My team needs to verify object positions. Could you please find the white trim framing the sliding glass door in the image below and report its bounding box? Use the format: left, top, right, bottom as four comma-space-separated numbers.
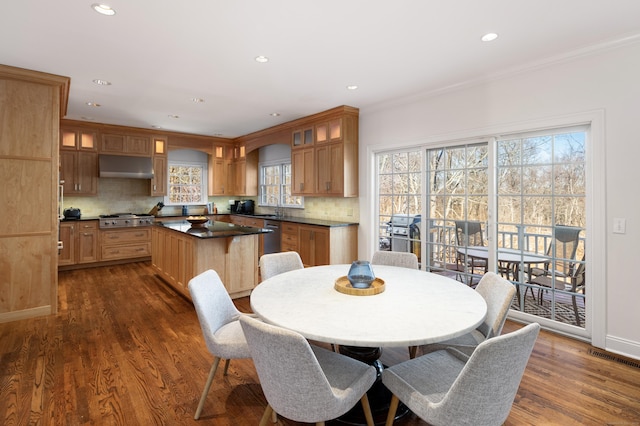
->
360, 109, 604, 353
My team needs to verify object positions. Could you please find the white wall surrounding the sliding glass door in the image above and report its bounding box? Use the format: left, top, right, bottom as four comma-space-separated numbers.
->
359, 38, 640, 358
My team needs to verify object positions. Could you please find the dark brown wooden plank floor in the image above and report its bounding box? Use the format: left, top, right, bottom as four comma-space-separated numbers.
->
0, 263, 640, 426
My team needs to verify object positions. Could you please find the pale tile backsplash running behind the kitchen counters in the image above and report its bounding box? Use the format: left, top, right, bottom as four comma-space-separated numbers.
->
64, 178, 360, 222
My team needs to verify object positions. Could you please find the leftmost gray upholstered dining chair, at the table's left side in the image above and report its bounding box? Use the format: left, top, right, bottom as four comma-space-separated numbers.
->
188, 269, 251, 420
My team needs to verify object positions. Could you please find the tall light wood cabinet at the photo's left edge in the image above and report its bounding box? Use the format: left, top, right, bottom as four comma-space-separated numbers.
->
0, 65, 69, 322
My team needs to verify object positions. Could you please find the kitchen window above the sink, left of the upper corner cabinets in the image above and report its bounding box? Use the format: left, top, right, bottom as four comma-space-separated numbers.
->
259, 163, 304, 208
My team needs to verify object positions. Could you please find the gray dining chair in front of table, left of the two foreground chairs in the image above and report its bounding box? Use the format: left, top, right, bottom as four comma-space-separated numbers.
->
240, 317, 376, 426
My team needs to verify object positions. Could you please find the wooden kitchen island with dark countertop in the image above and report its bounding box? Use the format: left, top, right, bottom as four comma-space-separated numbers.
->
151, 220, 271, 299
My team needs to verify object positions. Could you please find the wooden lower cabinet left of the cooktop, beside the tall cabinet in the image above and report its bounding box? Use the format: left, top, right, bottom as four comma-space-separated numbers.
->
58, 220, 99, 266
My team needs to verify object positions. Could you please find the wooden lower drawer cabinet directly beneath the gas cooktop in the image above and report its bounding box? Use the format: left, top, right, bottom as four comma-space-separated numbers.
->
100, 227, 151, 261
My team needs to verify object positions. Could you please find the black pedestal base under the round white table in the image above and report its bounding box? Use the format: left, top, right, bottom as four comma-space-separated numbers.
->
336, 346, 409, 425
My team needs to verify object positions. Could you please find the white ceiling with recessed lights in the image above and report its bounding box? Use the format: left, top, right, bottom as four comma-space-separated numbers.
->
0, 0, 640, 137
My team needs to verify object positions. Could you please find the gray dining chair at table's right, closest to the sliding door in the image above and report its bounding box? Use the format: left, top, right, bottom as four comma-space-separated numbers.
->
416, 272, 516, 358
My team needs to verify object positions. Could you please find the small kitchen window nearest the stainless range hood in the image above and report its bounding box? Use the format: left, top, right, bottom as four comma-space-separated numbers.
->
165, 150, 208, 206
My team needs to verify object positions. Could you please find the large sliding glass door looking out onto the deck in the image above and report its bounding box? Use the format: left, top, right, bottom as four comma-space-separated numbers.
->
376, 127, 588, 328
